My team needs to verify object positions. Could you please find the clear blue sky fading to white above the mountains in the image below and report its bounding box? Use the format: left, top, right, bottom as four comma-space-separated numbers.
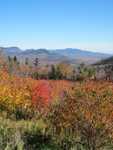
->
0, 0, 113, 53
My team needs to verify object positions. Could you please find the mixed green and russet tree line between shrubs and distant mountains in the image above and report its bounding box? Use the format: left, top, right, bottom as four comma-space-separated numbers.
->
7, 56, 95, 81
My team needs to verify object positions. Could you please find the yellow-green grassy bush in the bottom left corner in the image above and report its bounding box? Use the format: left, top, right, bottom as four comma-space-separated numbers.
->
0, 118, 58, 150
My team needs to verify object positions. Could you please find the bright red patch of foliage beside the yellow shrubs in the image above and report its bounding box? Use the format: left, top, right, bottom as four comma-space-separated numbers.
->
32, 80, 51, 106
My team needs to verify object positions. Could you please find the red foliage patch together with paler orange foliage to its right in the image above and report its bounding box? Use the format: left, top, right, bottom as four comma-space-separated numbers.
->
32, 80, 72, 105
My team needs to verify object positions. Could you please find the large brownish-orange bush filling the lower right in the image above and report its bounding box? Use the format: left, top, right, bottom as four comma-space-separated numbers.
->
47, 82, 113, 150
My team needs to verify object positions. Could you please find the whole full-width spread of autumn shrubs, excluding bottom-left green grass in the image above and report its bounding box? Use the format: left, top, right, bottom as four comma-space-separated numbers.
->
0, 68, 113, 150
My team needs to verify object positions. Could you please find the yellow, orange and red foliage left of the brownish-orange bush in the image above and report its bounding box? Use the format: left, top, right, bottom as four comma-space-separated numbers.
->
0, 71, 71, 115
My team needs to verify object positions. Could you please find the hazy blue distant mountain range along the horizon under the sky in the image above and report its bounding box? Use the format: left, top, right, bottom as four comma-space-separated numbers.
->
0, 47, 111, 64
